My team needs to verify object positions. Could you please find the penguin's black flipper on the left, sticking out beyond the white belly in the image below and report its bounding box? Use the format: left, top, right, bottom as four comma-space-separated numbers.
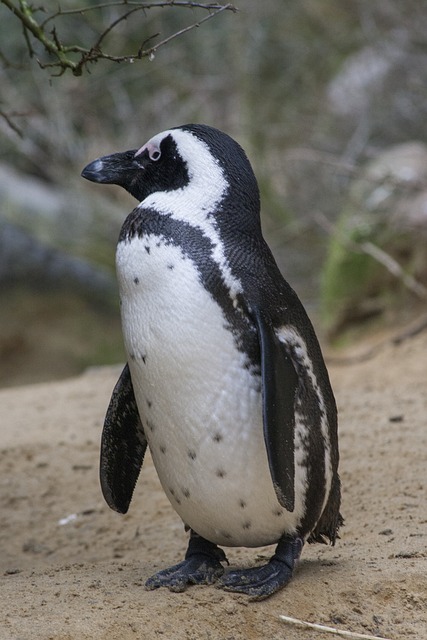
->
99, 365, 147, 513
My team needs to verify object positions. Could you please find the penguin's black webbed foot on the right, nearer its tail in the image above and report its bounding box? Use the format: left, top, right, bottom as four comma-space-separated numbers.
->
218, 538, 303, 600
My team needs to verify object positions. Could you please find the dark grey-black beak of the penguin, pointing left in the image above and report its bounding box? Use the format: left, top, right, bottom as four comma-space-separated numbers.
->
81, 149, 142, 186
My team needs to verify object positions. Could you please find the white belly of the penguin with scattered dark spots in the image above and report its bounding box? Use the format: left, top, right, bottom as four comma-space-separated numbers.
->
117, 235, 305, 547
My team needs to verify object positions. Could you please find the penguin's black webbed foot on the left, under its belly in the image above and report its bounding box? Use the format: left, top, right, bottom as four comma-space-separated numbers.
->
145, 532, 228, 592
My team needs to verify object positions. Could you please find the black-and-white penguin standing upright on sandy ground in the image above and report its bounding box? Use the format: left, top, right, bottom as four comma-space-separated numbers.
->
82, 124, 343, 599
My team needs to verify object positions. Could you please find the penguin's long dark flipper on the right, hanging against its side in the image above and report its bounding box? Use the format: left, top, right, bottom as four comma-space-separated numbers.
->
253, 308, 298, 511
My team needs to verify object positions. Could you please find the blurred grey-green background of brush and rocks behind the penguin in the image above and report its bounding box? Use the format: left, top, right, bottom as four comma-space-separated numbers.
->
0, 0, 427, 386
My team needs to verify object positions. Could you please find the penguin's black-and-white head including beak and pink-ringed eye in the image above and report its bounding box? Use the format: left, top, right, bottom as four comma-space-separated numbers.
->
82, 124, 259, 225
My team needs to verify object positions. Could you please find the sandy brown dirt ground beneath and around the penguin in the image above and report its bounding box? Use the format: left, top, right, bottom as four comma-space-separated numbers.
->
0, 322, 427, 640
